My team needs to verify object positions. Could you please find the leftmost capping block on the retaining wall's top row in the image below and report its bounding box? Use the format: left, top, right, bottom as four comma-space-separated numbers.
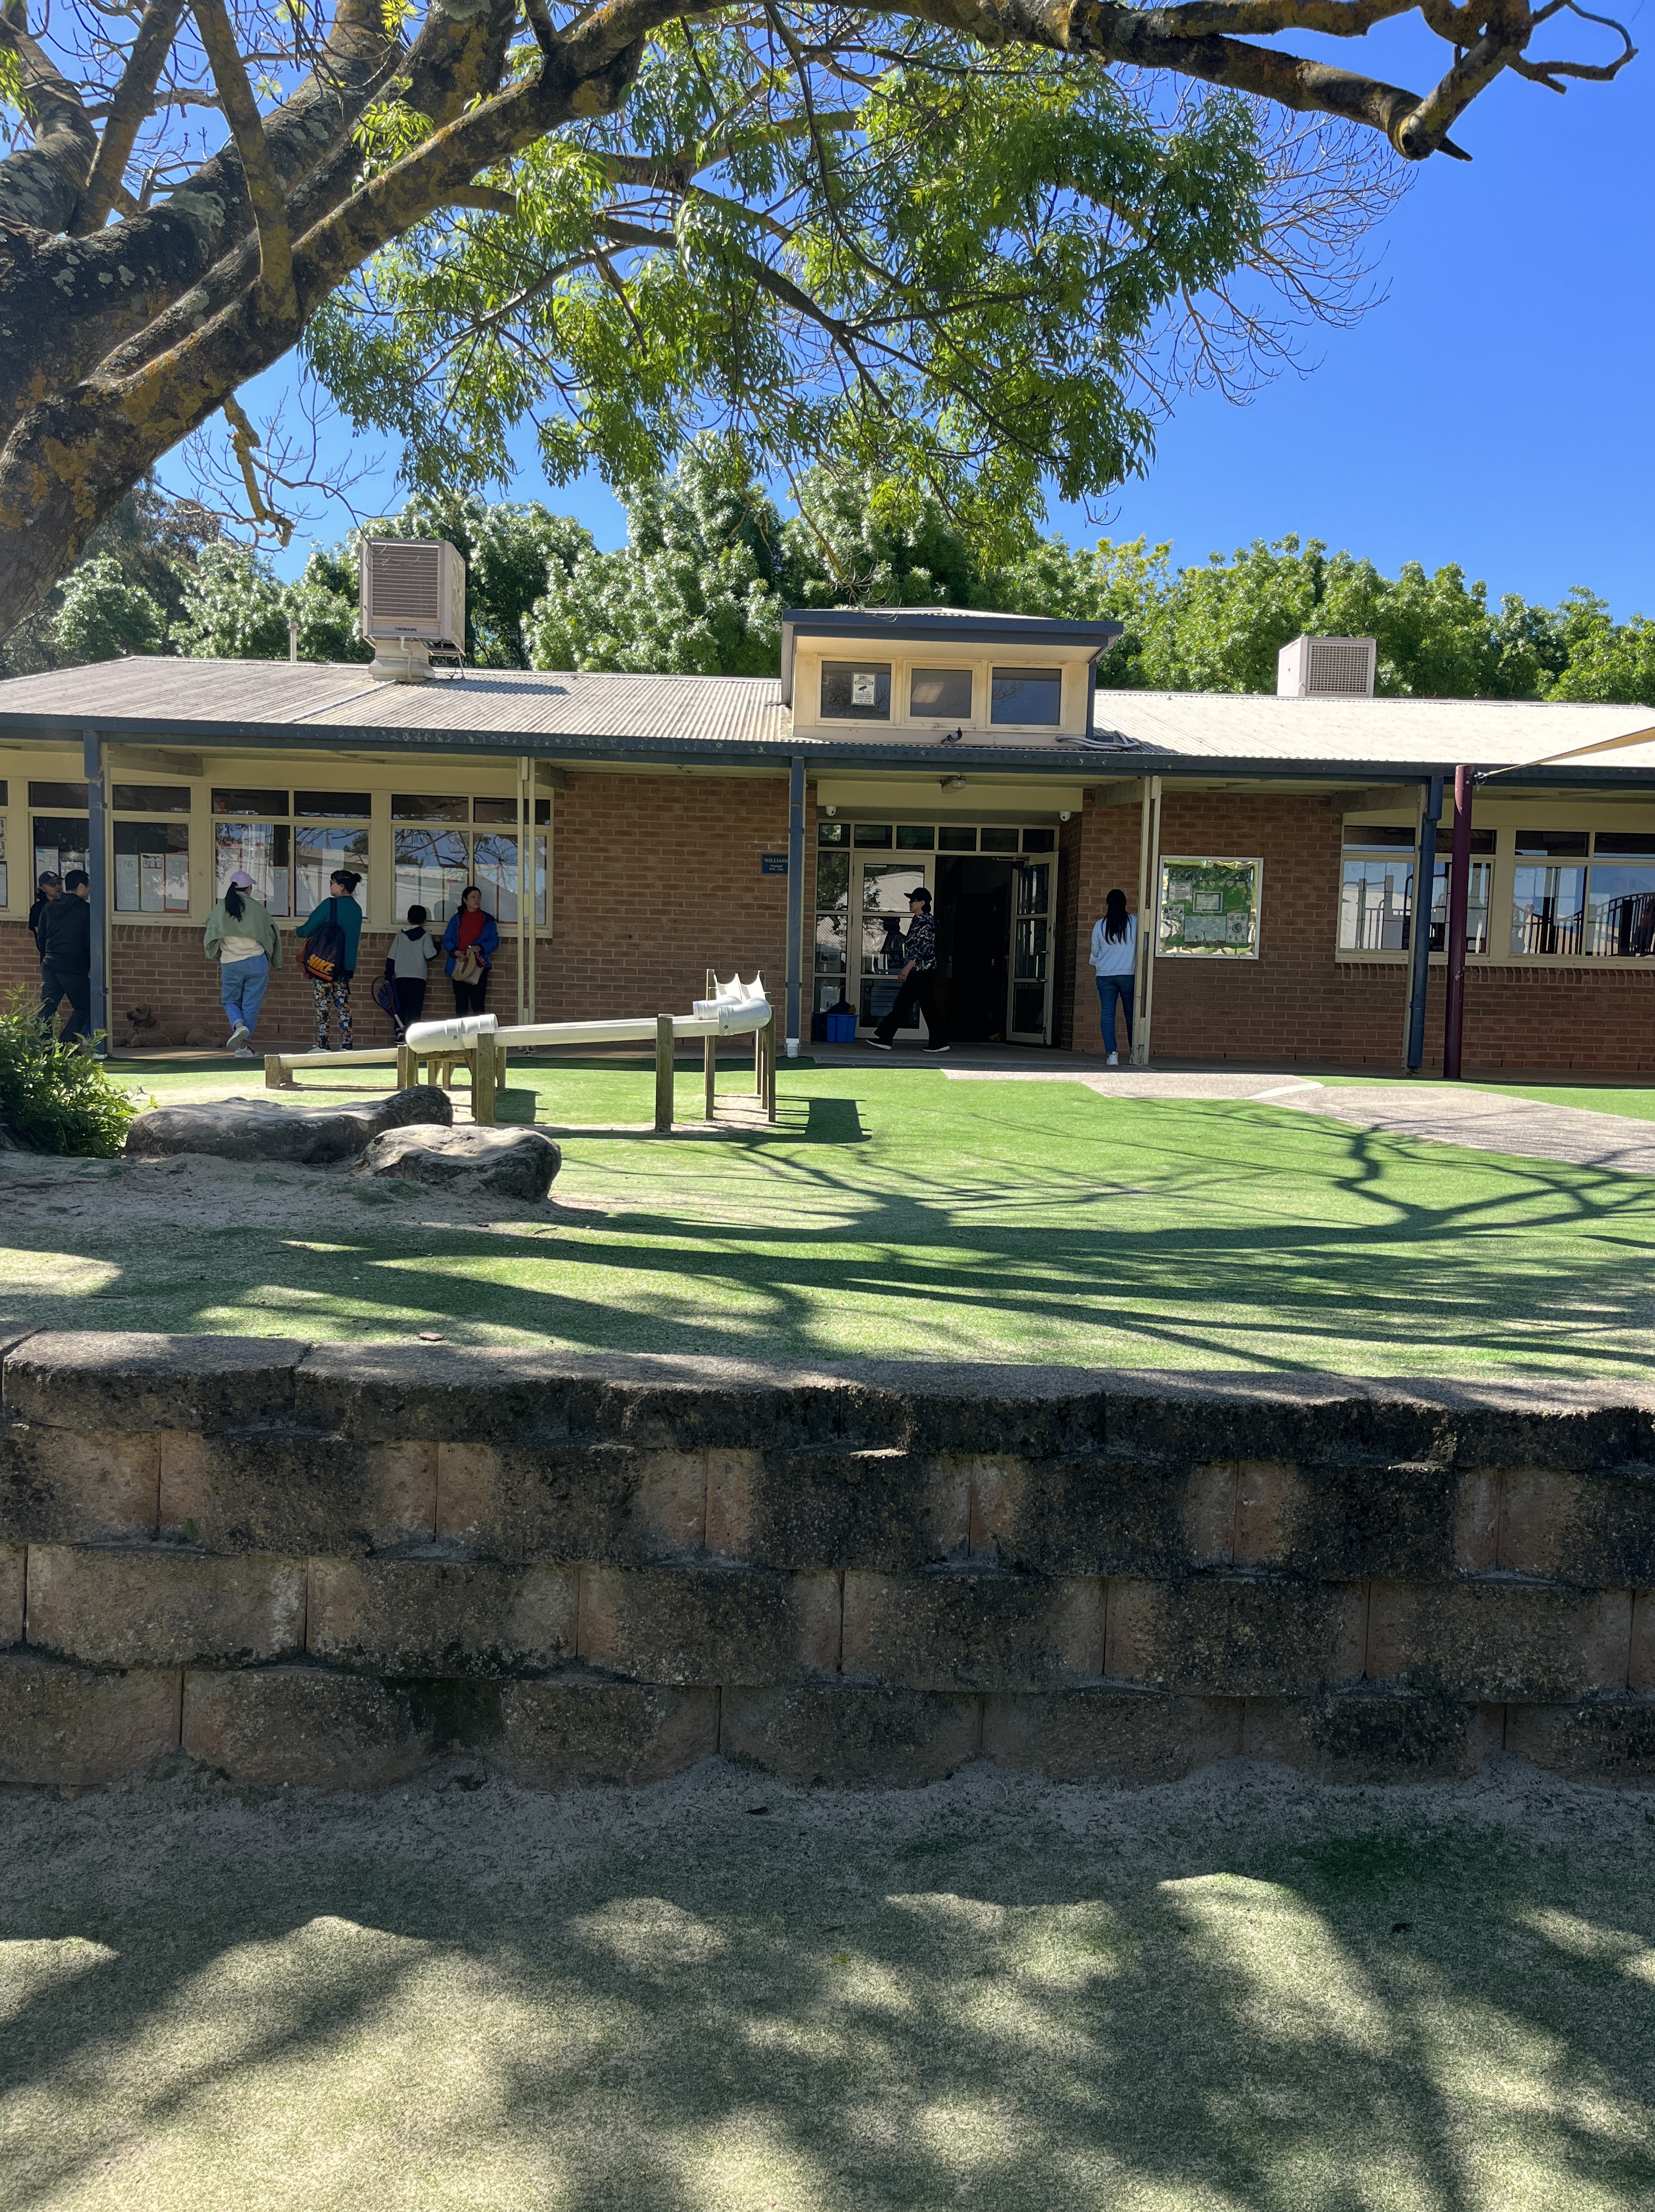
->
0, 1329, 310, 1431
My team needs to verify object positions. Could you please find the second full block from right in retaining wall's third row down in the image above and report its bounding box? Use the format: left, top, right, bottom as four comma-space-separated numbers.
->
1104, 1570, 1365, 1697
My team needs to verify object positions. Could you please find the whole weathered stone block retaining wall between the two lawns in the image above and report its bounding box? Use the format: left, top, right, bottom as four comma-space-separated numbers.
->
0, 1334, 1655, 1788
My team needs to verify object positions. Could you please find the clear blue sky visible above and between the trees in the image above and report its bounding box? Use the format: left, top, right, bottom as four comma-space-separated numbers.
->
248, 11, 1655, 617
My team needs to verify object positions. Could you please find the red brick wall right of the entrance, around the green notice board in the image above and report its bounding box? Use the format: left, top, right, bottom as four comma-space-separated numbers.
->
1073, 790, 1655, 1075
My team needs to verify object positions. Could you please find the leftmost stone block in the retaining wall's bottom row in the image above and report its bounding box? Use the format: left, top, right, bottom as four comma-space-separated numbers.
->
0, 1652, 179, 1790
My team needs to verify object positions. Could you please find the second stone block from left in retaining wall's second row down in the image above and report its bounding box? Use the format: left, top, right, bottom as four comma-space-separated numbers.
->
161, 1429, 436, 1553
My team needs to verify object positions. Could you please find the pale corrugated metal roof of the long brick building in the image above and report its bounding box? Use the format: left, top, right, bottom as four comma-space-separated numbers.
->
0, 657, 1655, 781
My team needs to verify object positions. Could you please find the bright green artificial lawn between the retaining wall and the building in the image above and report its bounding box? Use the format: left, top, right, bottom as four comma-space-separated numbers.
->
0, 1064, 1655, 1378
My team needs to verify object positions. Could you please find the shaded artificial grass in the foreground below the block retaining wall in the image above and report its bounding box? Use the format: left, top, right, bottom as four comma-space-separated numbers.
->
0, 1761, 1655, 2212
